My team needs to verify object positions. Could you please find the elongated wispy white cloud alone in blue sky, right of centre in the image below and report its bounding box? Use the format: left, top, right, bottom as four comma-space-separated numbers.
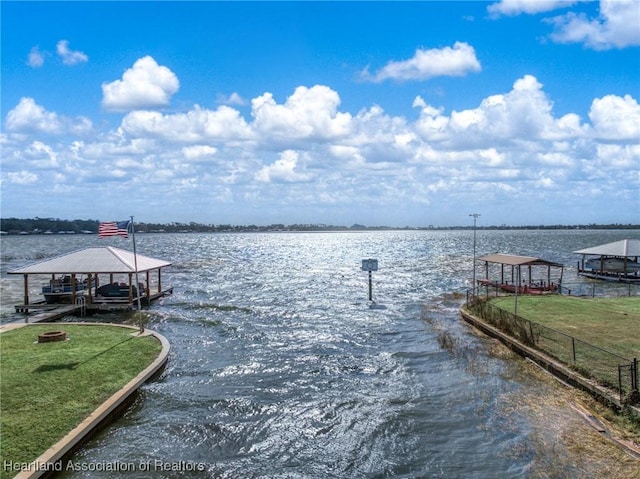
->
362, 42, 481, 82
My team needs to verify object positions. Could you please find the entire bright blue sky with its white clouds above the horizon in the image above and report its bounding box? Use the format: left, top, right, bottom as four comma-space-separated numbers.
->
0, 0, 640, 227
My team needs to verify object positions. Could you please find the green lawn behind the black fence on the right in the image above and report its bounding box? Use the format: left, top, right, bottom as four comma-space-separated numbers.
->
491, 295, 640, 359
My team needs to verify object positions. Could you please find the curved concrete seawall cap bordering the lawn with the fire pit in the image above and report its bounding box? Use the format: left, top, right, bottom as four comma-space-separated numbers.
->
2, 323, 171, 479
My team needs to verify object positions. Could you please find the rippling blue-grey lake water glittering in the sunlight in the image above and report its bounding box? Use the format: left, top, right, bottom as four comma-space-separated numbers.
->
1, 230, 640, 478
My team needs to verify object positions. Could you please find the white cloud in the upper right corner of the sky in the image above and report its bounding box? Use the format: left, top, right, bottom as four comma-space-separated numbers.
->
549, 0, 640, 50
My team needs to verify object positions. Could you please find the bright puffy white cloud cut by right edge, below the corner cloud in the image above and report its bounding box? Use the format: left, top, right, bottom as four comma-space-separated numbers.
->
589, 95, 640, 142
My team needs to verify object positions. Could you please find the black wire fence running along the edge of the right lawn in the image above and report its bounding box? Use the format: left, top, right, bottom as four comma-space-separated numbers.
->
467, 293, 639, 403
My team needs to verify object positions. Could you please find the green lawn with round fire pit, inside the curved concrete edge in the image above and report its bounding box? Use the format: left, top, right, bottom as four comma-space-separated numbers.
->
0, 324, 162, 479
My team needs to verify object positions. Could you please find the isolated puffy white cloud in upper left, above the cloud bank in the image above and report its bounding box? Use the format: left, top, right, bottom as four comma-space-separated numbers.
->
102, 56, 180, 111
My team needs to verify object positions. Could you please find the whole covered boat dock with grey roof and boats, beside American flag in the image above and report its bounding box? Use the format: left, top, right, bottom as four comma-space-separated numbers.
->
8, 246, 173, 313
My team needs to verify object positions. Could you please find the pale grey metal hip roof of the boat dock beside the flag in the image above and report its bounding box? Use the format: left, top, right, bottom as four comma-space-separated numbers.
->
8, 246, 171, 274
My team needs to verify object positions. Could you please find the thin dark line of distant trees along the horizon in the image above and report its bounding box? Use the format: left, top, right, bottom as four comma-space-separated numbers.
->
0, 217, 640, 234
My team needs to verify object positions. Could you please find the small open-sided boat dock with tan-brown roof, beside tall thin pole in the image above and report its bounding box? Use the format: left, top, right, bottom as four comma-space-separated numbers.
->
478, 253, 564, 294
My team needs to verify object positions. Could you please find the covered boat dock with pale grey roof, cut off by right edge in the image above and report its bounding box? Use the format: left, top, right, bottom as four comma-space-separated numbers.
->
574, 239, 640, 283
